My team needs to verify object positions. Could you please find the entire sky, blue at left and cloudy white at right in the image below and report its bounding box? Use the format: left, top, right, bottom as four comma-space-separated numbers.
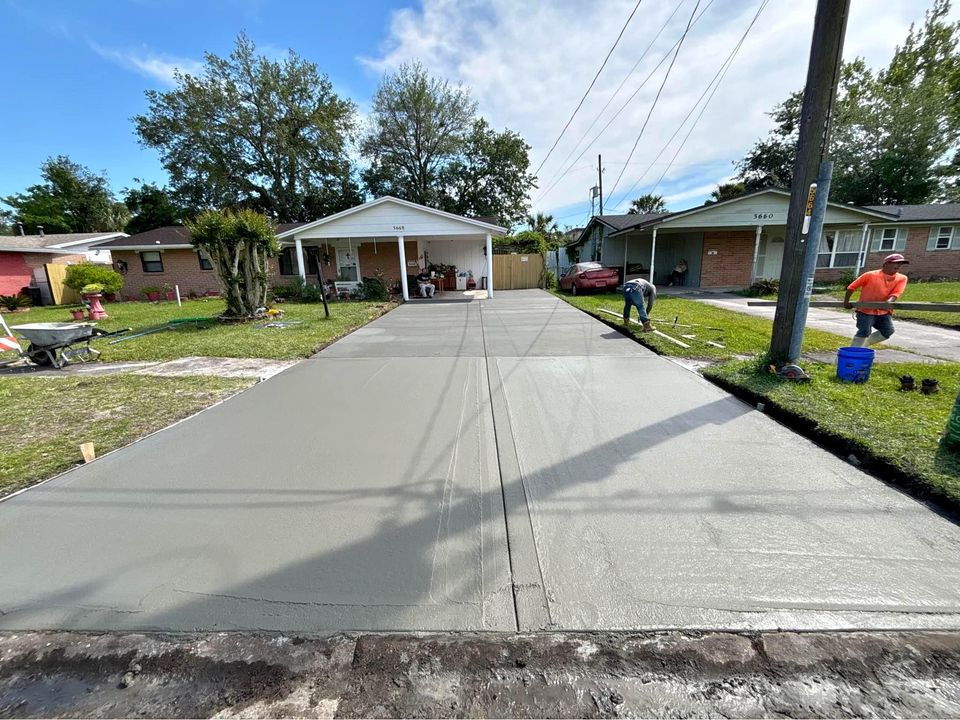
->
0, 0, 944, 225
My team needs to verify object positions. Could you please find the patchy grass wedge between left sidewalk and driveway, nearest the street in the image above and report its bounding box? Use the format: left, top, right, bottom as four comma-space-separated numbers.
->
0, 374, 252, 495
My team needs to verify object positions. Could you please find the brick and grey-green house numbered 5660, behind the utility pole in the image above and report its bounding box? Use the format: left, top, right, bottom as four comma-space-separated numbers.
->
568, 188, 960, 288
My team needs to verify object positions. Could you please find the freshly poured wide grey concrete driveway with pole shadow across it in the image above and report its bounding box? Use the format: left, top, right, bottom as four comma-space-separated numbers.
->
0, 291, 960, 631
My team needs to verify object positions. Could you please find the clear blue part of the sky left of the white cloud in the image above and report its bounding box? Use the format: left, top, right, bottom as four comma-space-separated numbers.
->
0, 0, 400, 196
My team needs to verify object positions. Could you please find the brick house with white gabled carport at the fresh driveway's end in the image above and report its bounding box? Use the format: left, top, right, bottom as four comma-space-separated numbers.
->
97, 196, 507, 299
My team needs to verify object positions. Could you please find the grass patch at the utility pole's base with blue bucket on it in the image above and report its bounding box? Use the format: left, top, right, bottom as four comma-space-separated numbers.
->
704, 361, 960, 507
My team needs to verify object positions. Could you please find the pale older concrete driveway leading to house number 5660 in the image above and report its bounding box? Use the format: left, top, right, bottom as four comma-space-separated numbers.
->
680, 291, 960, 362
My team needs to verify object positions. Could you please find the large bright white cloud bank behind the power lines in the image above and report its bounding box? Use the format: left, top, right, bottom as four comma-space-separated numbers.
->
361, 0, 956, 217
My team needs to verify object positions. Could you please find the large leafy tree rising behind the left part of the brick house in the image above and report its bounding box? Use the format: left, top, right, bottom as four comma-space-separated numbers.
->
134, 33, 362, 222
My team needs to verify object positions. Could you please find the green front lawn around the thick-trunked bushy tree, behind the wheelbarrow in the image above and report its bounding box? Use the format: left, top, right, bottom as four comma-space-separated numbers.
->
4, 298, 394, 361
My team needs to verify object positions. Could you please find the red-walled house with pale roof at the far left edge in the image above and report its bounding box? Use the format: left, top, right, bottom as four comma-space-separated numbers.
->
0, 232, 126, 303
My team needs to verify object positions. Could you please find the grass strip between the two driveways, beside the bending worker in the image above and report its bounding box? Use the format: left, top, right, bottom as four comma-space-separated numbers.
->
556, 292, 848, 360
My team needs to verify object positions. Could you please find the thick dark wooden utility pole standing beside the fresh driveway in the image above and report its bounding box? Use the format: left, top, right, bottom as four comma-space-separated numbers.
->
770, 0, 850, 362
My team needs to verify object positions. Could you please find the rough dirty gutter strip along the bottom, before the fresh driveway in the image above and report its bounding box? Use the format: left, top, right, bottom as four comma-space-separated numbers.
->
0, 632, 960, 718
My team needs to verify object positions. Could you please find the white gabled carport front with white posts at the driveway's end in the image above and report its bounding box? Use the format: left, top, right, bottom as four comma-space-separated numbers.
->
277, 196, 507, 301
